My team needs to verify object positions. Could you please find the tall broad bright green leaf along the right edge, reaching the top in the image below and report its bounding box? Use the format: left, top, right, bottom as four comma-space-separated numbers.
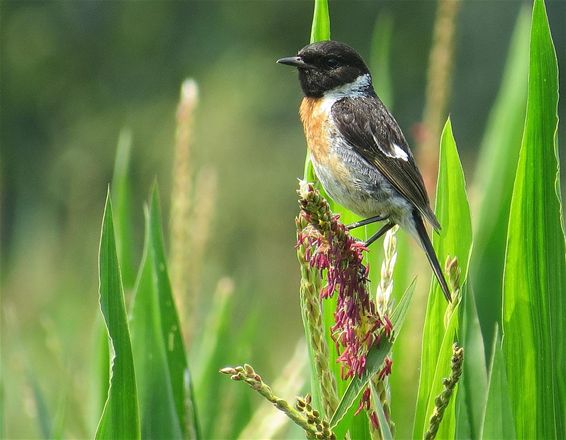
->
503, 0, 566, 438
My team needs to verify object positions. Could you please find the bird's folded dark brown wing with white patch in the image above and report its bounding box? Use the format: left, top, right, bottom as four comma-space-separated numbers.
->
331, 96, 440, 230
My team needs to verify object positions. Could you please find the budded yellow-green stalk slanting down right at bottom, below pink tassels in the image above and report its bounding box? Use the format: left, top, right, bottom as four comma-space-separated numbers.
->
220, 364, 336, 440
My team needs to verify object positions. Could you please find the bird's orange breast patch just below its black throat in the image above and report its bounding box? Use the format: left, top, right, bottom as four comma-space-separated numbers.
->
299, 98, 330, 163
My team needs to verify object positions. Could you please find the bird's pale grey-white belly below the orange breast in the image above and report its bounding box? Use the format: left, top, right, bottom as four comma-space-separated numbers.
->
312, 142, 412, 223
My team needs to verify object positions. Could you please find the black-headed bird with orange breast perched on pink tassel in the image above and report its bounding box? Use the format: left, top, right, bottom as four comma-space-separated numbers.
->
277, 40, 451, 302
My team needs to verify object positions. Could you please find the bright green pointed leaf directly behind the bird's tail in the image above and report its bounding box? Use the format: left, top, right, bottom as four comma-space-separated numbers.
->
413, 119, 472, 438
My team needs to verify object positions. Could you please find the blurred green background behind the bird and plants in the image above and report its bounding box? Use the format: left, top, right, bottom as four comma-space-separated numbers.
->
0, 0, 566, 438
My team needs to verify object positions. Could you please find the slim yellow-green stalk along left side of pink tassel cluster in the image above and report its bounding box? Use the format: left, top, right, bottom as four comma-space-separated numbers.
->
295, 211, 338, 416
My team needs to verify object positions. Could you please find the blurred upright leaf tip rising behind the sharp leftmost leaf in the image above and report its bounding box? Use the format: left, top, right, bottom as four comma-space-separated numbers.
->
112, 129, 135, 288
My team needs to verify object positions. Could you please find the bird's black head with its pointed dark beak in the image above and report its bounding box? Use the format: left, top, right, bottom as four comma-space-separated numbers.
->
277, 41, 372, 98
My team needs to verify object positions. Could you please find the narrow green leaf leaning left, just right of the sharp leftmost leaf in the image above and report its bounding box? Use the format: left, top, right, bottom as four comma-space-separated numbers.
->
149, 185, 200, 438
